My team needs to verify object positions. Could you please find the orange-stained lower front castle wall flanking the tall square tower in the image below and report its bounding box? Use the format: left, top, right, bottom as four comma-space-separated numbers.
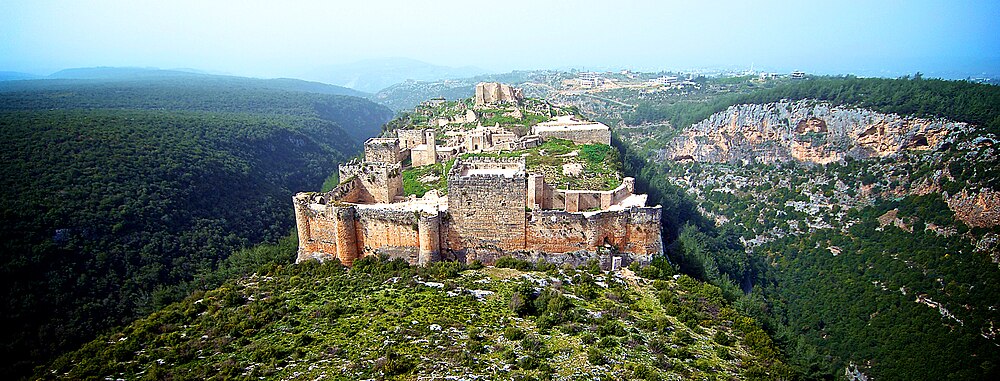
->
293, 189, 663, 269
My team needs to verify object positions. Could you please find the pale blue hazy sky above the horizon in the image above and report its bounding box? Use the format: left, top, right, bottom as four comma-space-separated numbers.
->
0, 0, 1000, 77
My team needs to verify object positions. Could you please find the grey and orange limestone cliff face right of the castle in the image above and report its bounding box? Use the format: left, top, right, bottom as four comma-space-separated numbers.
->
663, 100, 965, 164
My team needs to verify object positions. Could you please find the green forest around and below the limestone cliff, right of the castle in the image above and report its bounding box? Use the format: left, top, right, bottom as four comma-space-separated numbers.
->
616, 75, 1000, 379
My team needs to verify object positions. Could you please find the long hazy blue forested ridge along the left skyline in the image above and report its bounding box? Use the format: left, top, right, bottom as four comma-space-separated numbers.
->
0, 70, 382, 141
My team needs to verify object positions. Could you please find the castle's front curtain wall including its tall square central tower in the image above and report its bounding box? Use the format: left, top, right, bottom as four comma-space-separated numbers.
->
293, 158, 663, 269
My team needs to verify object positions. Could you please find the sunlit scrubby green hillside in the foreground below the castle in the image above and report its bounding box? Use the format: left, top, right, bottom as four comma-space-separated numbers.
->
35, 254, 787, 380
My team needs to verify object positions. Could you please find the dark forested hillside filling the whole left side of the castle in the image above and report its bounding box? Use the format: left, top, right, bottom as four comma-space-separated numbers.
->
0, 77, 391, 377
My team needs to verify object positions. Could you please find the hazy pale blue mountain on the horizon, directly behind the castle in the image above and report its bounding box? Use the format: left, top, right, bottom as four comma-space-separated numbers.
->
306, 58, 486, 93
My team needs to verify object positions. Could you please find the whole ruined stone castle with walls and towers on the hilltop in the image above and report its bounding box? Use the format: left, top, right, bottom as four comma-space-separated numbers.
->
293, 83, 663, 269
